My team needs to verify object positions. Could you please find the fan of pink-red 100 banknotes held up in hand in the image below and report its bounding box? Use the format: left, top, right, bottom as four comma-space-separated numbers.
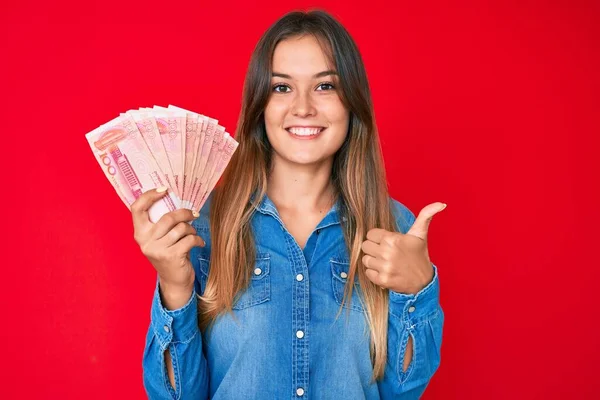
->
86, 105, 238, 222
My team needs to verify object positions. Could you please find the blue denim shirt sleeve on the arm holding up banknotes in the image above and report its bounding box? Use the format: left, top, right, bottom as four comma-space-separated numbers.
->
142, 277, 208, 400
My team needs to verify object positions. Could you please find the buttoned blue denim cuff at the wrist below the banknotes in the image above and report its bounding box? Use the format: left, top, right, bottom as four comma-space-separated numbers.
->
151, 279, 199, 349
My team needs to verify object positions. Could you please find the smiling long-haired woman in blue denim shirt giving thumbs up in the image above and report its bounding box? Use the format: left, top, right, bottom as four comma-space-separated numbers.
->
132, 7, 445, 400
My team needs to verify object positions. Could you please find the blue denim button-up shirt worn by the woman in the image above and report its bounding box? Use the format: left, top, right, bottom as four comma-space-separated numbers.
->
142, 195, 444, 400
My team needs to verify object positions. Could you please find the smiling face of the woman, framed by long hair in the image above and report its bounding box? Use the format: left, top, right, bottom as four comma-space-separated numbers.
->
264, 35, 350, 165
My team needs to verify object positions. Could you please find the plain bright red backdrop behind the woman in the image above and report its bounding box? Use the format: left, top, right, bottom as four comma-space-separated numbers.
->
0, 0, 600, 399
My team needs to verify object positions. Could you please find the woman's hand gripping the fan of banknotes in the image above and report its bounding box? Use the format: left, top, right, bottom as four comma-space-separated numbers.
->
131, 189, 205, 309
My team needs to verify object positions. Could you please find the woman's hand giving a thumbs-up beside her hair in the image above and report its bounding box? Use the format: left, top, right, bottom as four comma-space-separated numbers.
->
361, 202, 446, 294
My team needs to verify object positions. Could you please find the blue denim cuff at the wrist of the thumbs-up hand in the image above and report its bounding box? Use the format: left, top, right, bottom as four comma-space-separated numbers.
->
389, 264, 440, 321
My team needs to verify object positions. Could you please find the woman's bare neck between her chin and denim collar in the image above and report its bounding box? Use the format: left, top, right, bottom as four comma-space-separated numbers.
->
267, 155, 335, 212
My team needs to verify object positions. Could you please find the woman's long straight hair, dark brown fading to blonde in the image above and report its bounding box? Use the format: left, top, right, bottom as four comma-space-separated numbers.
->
199, 10, 396, 379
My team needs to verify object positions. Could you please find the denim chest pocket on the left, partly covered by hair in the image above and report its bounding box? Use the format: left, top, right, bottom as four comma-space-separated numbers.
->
198, 253, 271, 310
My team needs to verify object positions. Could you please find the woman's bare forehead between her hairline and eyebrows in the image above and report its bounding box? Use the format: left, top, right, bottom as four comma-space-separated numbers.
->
273, 35, 329, 77
